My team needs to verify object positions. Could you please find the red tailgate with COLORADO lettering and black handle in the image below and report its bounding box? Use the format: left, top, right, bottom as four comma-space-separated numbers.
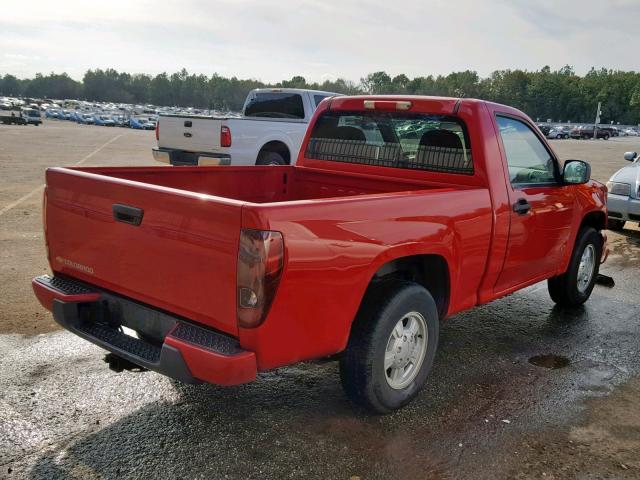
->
45, 168, 242, 335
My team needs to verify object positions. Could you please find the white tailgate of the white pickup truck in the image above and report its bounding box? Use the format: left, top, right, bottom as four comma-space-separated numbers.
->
158, 115, 224, 152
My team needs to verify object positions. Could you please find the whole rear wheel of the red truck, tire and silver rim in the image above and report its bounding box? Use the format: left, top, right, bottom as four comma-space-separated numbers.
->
340, 281, 439, 413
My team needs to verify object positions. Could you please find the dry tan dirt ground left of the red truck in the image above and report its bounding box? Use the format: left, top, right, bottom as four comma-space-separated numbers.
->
0, 121, 158, 334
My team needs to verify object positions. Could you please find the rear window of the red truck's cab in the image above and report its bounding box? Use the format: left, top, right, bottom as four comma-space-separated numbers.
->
305, 112, 473, 175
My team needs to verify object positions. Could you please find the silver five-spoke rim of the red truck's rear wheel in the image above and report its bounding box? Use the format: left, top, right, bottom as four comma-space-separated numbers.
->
384, 312, 428, 390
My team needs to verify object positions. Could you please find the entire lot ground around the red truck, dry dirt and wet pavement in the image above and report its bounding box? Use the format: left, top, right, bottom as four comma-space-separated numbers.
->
0, 121, 640, 479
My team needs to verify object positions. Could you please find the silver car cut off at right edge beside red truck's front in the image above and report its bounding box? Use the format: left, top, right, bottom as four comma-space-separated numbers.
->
607, 152, 640, 230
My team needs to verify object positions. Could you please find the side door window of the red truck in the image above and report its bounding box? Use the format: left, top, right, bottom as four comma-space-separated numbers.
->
497, 116, 557, 185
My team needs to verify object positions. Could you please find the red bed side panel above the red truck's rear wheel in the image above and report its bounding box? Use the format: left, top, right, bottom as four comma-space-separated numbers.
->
240, 188, 492, 369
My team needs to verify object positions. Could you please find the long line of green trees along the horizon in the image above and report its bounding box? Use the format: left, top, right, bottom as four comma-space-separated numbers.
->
0, 66, 640, 124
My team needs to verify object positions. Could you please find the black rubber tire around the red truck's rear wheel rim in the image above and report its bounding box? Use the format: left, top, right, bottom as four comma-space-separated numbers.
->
340, 281, 439, 413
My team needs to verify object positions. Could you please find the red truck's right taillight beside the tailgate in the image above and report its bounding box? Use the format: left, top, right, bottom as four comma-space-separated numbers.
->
236, 229, 284, 328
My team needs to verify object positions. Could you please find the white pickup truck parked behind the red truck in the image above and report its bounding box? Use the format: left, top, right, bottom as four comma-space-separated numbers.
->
153, 88, 337, 165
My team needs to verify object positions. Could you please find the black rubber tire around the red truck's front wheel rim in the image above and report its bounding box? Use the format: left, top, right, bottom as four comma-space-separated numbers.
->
547, 227, 602, 307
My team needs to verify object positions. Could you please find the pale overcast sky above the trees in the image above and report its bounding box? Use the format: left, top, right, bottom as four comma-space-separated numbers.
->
0, 0, 640, 82
